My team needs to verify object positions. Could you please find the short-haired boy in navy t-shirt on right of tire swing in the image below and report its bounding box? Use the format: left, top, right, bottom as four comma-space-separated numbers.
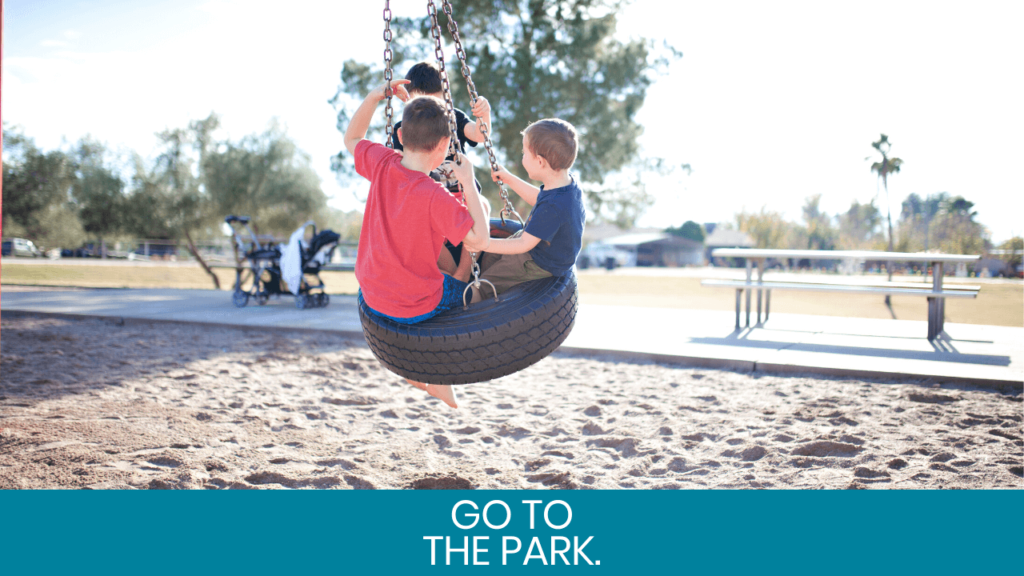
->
473, 118, 587, 302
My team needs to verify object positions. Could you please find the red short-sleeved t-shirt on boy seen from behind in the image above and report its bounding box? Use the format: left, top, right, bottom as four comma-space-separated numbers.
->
355, 140, 473, 318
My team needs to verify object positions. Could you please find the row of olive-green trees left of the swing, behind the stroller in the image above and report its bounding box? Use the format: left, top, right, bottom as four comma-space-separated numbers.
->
3, 114, 327, 248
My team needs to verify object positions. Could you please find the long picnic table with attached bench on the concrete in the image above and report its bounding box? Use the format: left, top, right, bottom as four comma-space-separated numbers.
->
701, 248, 981, 340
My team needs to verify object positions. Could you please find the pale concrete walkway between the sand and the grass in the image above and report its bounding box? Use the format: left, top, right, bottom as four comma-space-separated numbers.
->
0, 286, 1024, 392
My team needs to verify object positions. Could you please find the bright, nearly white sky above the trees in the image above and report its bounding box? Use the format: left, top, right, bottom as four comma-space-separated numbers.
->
0, 0, 1024, 243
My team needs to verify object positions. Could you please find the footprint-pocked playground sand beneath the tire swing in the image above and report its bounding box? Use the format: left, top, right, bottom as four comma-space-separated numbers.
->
0, 318, 1024, 489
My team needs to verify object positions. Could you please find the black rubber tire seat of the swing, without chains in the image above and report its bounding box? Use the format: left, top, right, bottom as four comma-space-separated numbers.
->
359, 271, 580, 384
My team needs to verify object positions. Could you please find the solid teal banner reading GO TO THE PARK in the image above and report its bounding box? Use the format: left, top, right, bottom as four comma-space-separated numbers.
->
0, 491, 1024, 576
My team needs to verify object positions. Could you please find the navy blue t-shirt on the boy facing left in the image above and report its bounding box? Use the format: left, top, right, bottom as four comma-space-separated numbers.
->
526, 178, 587, 276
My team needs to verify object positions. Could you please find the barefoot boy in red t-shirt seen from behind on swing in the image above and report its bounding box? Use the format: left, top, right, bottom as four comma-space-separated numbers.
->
345, 80, 490, 408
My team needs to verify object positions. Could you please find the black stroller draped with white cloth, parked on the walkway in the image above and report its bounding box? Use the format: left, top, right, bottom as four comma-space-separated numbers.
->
224, 215, 340, 310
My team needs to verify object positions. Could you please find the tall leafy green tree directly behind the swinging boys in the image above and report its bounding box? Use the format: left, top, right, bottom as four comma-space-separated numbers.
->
332, 0, 681, 227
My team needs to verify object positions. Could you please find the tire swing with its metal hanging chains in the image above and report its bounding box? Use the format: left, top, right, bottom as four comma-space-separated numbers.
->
359, 0, 580, 384
